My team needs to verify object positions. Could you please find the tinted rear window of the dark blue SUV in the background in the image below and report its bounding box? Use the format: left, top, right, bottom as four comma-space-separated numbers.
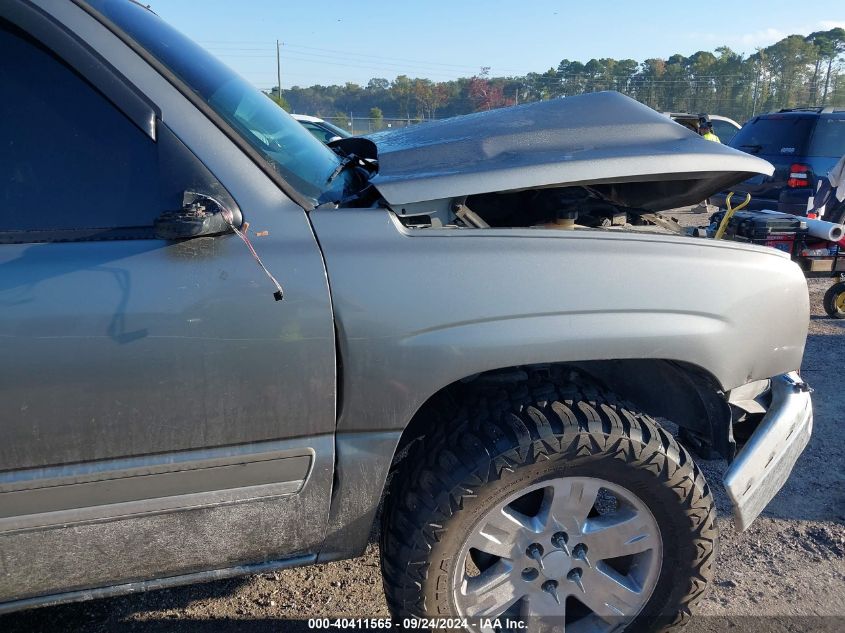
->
731, 114, 815, 156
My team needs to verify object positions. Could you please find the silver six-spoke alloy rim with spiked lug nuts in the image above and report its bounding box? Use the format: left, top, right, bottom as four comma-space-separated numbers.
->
452, 477, 662, 632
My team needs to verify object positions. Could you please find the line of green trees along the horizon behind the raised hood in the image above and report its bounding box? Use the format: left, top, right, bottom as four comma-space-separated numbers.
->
270, 28, 845, 123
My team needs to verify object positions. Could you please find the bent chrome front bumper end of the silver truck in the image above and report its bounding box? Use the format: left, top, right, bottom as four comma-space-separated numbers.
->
723, 372, 813, 532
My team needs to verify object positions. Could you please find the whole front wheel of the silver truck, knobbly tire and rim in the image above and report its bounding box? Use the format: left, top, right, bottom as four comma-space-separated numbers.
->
382, 372, 717, 631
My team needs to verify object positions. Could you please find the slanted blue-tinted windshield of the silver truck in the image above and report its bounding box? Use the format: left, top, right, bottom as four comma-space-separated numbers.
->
88, 0, 347, 205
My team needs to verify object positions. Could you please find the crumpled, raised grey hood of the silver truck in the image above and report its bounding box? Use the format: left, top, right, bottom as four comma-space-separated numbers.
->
368, 92, 774, 211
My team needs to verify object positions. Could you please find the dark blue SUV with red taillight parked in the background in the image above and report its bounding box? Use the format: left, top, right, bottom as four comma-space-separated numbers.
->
710, 107, 845, 215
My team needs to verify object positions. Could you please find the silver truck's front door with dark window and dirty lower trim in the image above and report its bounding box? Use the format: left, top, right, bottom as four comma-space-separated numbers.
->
0, 2, 335, 602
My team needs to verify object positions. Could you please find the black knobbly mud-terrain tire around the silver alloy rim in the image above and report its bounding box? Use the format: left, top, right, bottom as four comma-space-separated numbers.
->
381, 372, 718, 631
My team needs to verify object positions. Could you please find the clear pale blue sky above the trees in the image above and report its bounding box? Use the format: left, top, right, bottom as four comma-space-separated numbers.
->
153, 0, 845, 89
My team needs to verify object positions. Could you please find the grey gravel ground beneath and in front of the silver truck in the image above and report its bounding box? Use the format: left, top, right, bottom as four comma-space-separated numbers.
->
0, 214, 845, 633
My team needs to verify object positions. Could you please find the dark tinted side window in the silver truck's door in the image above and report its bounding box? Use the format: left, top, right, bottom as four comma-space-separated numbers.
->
0, 21, 161, 235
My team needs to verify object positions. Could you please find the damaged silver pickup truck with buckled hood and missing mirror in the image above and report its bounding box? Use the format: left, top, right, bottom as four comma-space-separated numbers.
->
0, 0, 812, 631
